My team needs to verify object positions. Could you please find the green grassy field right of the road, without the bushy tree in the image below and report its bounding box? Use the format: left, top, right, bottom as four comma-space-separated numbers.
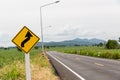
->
50, 46, 120, 59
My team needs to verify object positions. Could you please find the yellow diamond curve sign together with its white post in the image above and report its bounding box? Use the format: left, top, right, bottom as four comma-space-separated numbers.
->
12, 26, 39, 80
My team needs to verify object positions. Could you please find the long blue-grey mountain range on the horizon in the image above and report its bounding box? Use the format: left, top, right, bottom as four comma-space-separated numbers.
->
37, 38, 106, 46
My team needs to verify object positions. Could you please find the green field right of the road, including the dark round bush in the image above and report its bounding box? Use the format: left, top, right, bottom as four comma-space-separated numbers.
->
46, 38, 120, 59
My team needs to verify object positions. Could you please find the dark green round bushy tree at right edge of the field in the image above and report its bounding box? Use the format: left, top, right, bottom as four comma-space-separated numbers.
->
106, 40, 119, 49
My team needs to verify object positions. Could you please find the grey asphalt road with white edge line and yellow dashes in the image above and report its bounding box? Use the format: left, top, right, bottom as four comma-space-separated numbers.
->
46, 51, 120, 80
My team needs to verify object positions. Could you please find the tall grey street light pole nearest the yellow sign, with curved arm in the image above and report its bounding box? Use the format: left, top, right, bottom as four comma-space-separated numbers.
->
40, 1, 60, 54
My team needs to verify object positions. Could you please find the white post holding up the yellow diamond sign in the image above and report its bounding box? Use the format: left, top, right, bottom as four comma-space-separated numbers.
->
25, 53, 31, 80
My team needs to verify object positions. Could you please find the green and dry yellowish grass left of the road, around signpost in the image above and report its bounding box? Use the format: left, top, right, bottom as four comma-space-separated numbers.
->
0, 48, 59, 80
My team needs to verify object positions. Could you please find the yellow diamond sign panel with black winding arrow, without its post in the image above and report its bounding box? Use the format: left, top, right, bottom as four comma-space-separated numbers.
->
12, 26, 39, 53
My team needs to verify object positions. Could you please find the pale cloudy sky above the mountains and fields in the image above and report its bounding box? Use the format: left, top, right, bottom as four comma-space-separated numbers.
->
0, 0, 120, 47
